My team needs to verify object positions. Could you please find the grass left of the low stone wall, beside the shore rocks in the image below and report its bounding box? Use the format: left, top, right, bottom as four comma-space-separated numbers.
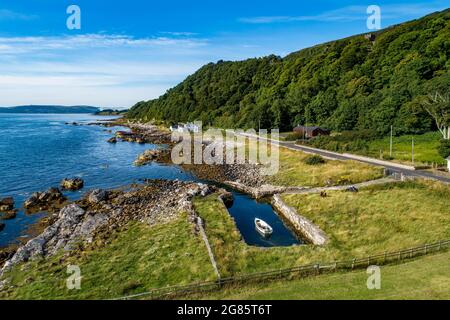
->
0, 216, 215, 299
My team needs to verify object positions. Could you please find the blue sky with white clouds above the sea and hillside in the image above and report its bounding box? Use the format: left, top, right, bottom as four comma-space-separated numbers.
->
0, 0, 450, 108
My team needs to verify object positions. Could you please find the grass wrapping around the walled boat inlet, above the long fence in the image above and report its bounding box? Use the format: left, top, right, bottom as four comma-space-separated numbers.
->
195, 182, 450, 276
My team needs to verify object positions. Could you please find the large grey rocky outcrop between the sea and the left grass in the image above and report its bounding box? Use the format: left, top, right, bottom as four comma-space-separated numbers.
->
2, 180, 221, 280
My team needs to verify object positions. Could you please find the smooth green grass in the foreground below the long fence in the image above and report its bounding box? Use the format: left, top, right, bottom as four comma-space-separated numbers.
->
200, 252, 450, 300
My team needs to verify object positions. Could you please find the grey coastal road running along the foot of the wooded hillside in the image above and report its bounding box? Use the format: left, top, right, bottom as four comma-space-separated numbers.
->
239, 134, 450, 184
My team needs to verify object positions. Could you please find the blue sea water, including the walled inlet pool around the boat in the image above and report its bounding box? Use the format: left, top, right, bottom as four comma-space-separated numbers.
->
0, 114, 299, 246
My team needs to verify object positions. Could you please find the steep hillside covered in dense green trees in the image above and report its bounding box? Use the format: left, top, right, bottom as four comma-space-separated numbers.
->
128, 9, 450, 134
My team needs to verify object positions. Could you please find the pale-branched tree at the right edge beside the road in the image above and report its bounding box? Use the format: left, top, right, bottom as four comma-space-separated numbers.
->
422, 91, 450, 140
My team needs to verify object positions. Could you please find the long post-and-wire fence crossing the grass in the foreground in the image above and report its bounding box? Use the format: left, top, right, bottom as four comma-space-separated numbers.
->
112, 239, 450, 300
